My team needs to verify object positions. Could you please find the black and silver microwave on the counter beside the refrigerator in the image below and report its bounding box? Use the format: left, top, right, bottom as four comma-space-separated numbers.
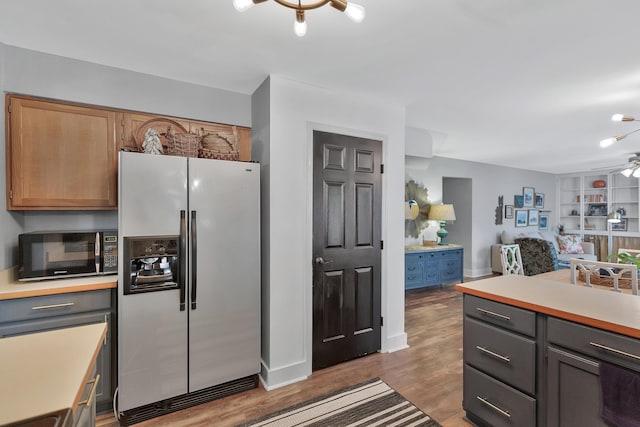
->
18, 230, 118, 280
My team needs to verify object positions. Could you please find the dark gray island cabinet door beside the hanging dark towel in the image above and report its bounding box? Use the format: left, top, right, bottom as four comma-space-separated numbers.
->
547, 347, 606, 427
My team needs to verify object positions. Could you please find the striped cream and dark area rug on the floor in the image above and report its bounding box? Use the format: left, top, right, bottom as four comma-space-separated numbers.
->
238, 378, 440, 427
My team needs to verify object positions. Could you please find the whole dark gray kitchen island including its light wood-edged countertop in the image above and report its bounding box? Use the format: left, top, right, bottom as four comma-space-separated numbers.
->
457, 276, 640, 427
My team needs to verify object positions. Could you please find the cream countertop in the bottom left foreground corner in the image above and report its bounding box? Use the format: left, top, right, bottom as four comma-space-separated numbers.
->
0, 323, 107, 425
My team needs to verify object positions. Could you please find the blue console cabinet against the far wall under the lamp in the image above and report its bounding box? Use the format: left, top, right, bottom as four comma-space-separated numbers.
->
404, 245, 464, 289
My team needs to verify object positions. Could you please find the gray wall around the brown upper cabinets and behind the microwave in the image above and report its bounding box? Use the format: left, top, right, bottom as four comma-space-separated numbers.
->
0, 43, 251, 269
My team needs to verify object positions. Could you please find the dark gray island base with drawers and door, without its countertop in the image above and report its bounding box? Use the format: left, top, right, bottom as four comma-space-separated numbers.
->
462, 294, 640, 427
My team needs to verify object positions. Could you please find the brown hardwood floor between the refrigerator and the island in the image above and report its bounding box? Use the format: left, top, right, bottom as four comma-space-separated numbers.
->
97, 285, 471, 427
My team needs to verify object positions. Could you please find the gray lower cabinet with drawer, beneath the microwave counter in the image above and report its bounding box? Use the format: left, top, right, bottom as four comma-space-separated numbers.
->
0, 289, 114, 413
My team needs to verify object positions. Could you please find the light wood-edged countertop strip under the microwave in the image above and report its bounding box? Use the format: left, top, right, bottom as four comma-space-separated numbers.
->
0, 267, 118, 300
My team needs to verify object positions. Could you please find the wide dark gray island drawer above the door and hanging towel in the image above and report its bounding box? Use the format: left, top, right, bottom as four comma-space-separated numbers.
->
547, 317, 640, 371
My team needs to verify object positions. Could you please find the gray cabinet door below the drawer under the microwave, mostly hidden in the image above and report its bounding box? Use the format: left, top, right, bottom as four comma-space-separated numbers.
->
0, 311, 112, 410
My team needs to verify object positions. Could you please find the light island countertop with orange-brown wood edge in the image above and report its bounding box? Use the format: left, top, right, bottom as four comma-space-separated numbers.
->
456, 275, 640, 338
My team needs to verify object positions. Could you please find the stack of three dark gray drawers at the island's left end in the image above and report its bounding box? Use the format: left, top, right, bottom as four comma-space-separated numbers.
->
462, 295, 539, 427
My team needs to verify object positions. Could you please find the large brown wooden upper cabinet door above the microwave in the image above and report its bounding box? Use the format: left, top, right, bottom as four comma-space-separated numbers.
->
7, 96, 117, 210
